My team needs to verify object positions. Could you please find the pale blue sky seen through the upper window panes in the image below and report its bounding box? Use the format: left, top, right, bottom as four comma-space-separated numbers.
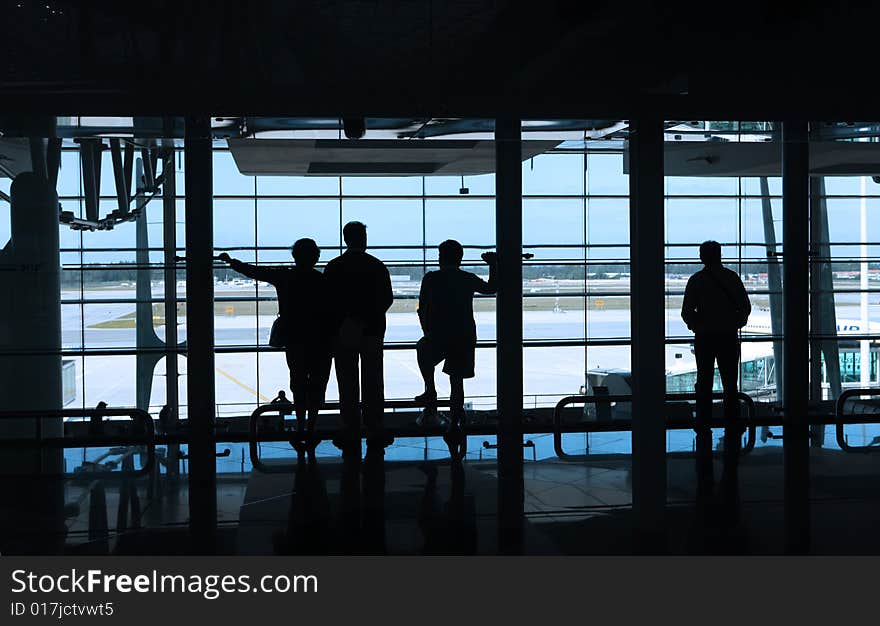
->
0, 151, 880, 263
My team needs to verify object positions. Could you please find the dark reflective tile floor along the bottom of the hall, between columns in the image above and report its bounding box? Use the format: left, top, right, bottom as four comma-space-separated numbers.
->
0, 448, 880, 554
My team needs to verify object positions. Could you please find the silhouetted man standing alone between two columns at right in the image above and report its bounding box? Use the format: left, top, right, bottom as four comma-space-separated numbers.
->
681, 241, 752, 430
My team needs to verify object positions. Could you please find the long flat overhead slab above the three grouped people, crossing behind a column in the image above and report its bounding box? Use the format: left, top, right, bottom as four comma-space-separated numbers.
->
227, 139, 560, 176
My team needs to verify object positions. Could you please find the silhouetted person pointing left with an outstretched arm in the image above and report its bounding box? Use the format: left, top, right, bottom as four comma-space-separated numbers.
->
219, 239, 332, 447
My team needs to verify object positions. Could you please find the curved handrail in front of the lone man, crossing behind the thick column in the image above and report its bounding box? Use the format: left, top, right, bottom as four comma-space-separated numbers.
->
553, 392, 757, 461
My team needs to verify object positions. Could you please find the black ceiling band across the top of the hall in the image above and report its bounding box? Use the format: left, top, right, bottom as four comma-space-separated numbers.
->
0, 0, 880, 119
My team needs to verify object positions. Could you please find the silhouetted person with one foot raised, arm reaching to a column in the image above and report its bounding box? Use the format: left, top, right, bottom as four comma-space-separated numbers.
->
416, 239, 498, 430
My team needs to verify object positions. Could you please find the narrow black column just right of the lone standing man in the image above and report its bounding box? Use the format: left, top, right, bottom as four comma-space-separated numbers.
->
782, 122, 810, 553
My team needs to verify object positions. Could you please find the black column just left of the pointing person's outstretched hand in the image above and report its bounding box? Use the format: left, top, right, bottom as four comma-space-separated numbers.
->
184, 117, 217, 553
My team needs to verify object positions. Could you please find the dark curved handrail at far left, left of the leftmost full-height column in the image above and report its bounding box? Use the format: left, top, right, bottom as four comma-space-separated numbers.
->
0, 407, 156, 477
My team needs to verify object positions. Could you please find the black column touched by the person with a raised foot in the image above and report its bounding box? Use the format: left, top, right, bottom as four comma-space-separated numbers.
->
495, 118, 523, 553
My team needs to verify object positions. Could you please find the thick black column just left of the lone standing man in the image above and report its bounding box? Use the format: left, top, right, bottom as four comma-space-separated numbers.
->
629, 118, 666, 551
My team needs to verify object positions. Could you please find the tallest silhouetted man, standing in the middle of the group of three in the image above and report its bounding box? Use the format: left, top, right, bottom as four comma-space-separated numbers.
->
324, 222, 394, 456
